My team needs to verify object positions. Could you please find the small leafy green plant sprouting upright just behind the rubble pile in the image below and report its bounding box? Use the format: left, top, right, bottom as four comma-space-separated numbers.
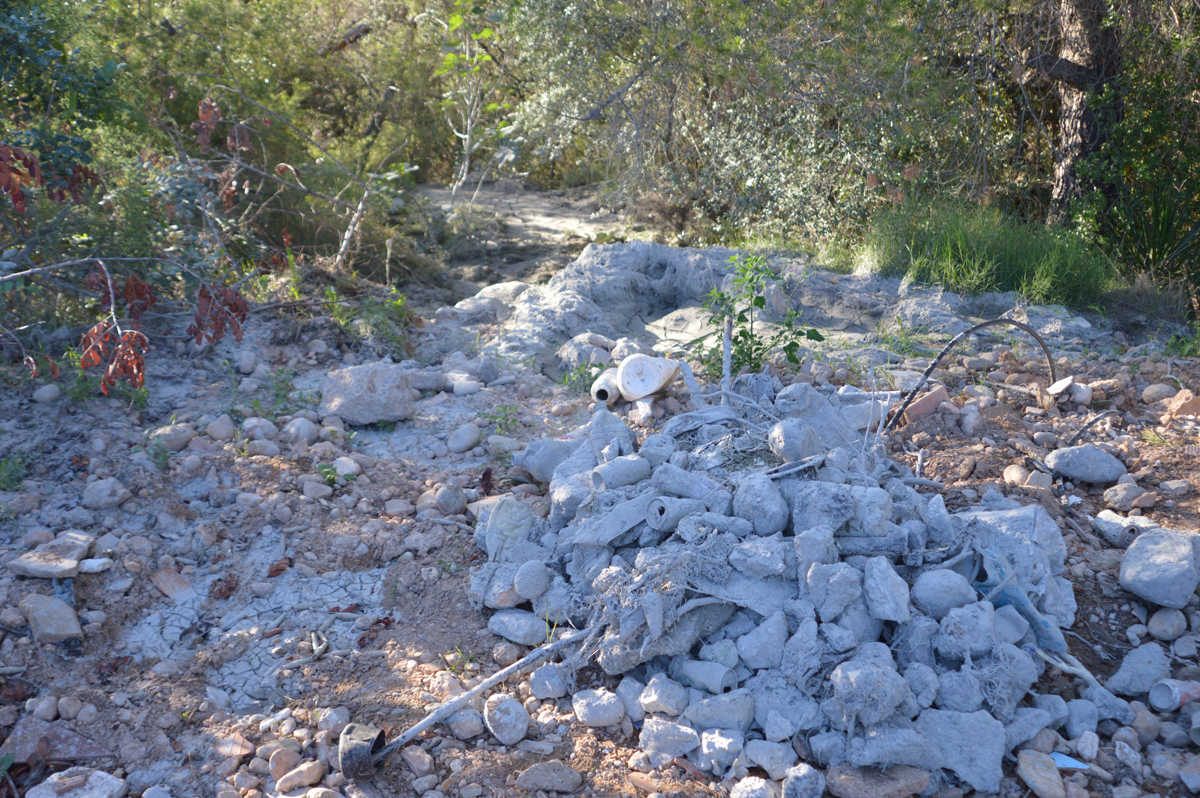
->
700, 254, 824, 379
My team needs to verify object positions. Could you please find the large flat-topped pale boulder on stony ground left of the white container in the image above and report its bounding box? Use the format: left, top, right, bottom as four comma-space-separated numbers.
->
317, 362, 418, 425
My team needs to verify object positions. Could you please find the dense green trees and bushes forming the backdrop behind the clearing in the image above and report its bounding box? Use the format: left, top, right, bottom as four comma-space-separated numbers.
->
0, 0, 1200, 331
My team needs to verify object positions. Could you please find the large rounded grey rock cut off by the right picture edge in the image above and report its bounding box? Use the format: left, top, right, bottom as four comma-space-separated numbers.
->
1121, 529, 1200, 610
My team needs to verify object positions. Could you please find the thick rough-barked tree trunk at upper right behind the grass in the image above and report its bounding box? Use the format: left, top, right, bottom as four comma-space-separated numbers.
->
1028, 0, 1121, 221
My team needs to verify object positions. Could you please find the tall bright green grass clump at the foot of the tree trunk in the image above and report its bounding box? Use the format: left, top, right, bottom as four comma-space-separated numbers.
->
856, 200, 1115, 307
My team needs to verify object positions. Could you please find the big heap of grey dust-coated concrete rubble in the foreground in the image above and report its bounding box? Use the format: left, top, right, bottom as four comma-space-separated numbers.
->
472, 360, 1200, 798
